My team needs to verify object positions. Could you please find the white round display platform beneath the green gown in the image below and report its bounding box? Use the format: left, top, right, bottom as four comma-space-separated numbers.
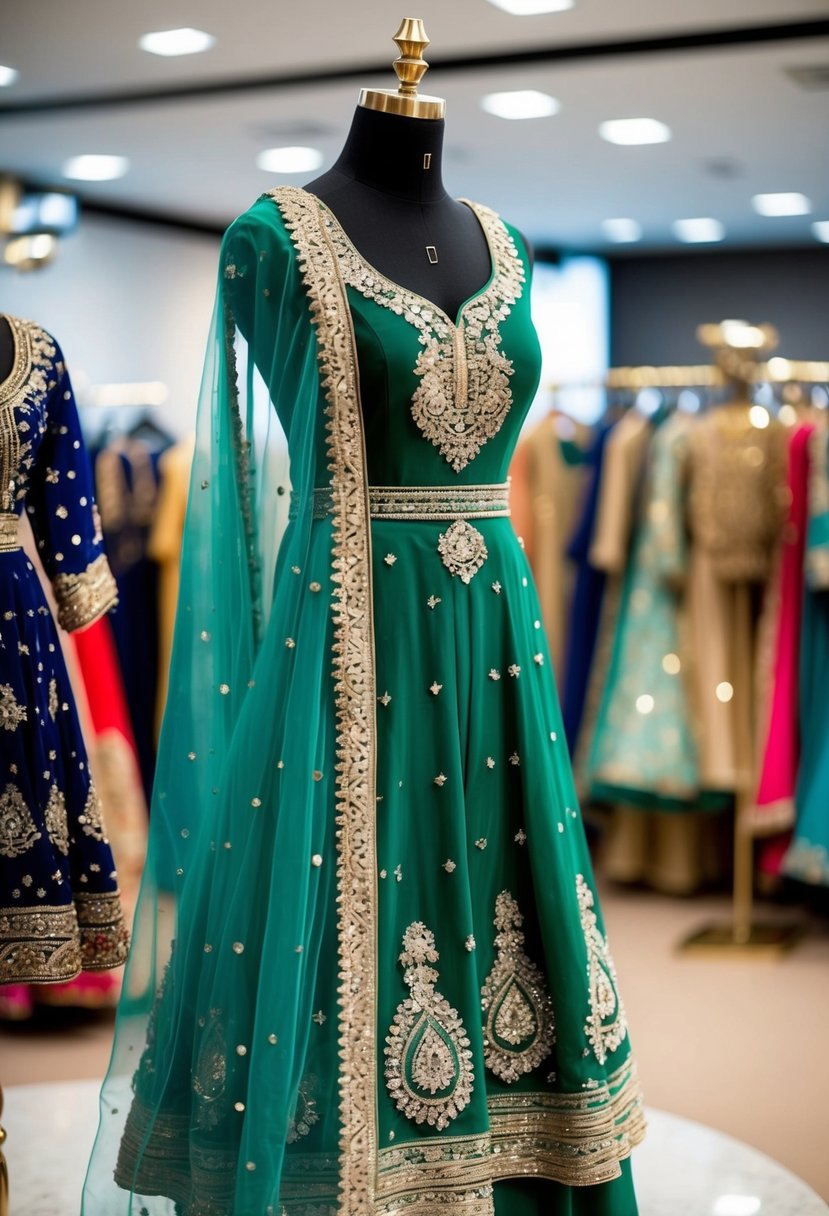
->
2, 1081, 829, 1216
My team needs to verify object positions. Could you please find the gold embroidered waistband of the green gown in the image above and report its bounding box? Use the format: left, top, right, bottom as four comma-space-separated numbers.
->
306, 482, 509, 520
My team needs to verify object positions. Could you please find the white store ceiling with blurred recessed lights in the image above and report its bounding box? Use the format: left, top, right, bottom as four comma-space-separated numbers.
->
0, 0, 829, 248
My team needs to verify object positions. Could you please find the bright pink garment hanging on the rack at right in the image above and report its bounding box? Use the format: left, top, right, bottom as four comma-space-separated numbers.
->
751, 423, 814, 846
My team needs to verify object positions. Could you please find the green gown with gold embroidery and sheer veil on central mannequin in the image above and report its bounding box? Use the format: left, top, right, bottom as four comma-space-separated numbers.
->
84, 190, 643, 1216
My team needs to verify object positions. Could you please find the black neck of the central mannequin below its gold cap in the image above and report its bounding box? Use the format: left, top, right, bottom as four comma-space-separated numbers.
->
331, 106, 446, 203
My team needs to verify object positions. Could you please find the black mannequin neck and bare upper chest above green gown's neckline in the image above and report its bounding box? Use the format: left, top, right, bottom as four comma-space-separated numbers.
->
305, 106, 492, 317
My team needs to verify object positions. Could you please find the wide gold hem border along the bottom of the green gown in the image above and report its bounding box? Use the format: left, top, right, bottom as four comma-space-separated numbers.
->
115, 1059, 645, 1216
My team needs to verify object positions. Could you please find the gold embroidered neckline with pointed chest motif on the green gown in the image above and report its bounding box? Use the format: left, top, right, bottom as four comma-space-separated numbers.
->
323, 203, 525, 473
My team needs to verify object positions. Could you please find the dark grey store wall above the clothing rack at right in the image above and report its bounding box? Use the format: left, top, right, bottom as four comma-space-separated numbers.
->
610, 247, 829, 366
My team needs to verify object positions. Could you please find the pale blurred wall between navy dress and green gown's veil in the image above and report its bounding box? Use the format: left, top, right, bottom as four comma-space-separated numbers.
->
0, 216, 219, 434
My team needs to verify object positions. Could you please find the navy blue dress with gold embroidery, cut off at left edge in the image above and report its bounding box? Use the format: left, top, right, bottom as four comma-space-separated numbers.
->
0, 316, 128, 984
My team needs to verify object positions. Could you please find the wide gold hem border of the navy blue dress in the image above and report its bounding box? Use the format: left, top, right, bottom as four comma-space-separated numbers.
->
0, 891, 129, 984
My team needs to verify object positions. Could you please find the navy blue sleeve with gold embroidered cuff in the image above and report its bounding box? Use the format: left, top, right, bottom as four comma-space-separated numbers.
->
26, 344, 118, 631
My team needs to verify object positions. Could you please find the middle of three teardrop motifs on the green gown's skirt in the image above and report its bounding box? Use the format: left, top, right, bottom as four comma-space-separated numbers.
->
480, 891, 556, 1085
